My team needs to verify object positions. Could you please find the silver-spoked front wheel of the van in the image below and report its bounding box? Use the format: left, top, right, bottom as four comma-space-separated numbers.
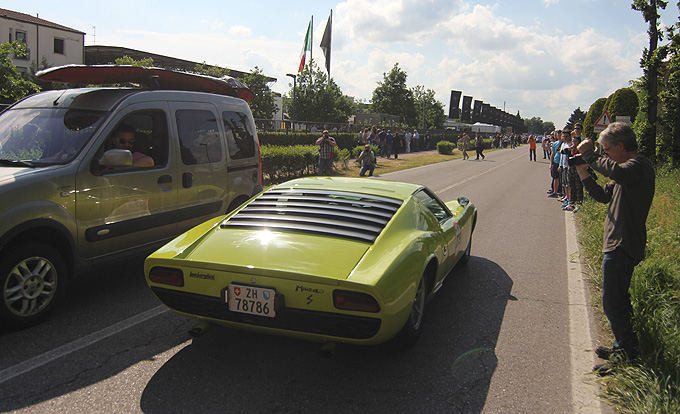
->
0, 243, 67, 329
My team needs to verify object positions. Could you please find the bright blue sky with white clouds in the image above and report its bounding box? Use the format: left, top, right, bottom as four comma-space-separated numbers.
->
13, 0, 678, 128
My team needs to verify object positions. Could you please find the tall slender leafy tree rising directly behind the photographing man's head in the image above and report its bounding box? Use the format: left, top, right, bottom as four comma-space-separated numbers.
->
631, 0, 667, 162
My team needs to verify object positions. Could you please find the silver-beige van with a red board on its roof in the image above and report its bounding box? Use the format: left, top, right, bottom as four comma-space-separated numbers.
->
0, 66, 262, 328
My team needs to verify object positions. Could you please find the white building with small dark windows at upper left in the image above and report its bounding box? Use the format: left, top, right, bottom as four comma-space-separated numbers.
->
0, 9, 85, 72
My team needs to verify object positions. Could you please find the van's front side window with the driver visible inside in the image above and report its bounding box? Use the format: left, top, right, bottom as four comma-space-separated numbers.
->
92, 110, 169, 174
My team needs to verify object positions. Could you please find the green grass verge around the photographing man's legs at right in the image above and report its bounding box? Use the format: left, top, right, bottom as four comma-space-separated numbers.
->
577, 167, 680, 413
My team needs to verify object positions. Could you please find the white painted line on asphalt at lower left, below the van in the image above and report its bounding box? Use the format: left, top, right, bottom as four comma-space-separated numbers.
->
0, 305, 168, 384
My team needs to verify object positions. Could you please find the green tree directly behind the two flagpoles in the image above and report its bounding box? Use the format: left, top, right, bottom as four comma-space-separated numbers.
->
290, 60, 354, 123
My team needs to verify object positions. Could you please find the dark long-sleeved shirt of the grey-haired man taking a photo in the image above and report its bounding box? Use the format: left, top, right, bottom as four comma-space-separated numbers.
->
583, 151, 655, 261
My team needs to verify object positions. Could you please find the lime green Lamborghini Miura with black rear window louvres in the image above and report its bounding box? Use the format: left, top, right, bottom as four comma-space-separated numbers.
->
144, 177, 477, 345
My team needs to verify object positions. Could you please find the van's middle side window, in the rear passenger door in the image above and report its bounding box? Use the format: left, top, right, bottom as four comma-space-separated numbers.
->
175, 109, 222, 165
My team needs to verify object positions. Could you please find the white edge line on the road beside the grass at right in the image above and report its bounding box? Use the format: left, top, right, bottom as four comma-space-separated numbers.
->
564, 212, 602, 413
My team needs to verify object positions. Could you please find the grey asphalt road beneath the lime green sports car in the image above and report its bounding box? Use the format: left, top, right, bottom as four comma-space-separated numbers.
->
0, 147, 608, 413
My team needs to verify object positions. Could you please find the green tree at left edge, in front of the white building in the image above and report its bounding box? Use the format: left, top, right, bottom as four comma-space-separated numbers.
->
0, 42, 40, 103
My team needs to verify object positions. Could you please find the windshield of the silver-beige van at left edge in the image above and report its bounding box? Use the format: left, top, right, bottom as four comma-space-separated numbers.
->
0, 108, 106, 166
